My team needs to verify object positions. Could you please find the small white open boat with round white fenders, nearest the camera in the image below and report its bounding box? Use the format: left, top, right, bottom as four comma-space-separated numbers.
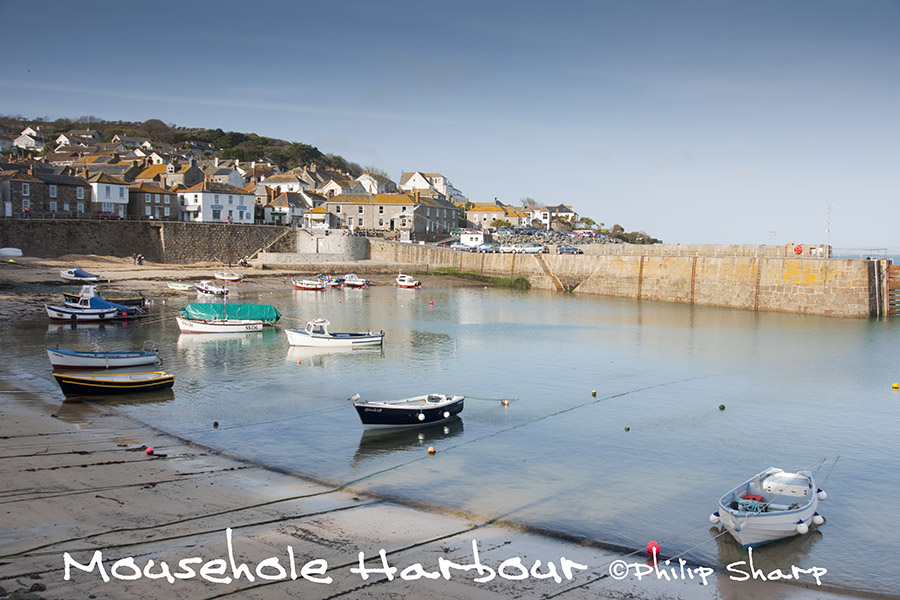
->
709, 467, 826, 548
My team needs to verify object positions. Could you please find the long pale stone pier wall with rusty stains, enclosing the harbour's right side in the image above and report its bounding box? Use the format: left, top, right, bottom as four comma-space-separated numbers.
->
371, 241, 882, 317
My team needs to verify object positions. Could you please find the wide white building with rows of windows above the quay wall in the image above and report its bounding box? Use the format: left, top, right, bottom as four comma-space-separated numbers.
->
178, 181, 254, 225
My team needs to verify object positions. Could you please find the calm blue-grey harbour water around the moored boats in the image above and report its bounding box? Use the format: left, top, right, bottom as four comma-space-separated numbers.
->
4, 287, 900, 592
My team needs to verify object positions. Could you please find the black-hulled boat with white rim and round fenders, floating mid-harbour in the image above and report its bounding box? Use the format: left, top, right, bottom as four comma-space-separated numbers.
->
353, 394, 465, 428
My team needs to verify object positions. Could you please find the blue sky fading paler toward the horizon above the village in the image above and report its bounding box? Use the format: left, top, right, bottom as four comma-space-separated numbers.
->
0, 0, 900, 249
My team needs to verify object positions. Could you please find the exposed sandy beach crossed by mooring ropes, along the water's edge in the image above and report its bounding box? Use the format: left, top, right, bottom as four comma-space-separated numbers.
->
0, 257, 873, 600
